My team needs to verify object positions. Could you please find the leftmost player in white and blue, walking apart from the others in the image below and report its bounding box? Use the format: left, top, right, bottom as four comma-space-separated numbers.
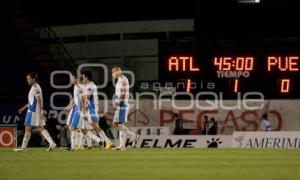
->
14, 72, 56, 152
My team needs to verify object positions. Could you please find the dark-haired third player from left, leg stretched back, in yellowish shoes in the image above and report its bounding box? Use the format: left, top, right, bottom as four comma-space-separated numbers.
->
82, 71, 113, 149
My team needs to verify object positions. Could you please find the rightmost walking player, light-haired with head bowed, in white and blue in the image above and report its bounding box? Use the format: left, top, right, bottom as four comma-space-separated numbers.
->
112, 66, 138, 150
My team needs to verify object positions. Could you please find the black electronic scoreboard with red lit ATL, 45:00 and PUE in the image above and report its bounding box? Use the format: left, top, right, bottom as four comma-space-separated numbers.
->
159, 39, 300, 99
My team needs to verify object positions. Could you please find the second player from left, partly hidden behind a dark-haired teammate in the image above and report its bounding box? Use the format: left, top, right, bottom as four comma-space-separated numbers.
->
65, 74, 86, 151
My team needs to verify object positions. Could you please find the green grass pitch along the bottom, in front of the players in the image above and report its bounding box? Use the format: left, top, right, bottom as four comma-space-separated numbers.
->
0, 148, 300, 180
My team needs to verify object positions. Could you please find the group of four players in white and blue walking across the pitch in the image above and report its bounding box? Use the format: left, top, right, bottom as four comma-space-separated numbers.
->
14, 66, 138, 152
